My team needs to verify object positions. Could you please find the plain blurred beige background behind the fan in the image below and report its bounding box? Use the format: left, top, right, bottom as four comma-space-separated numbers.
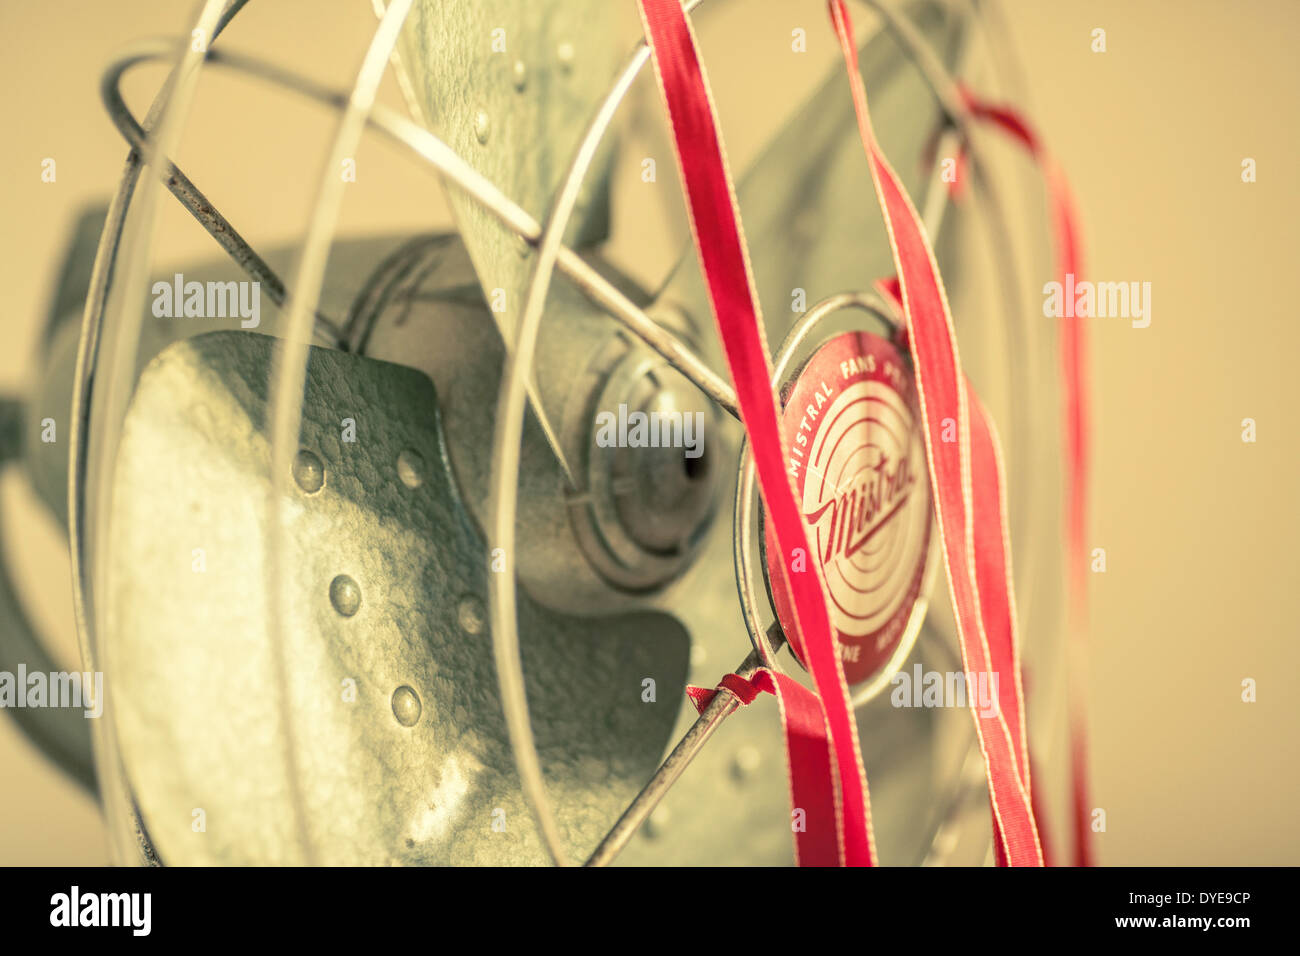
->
0, 0, 1300, 864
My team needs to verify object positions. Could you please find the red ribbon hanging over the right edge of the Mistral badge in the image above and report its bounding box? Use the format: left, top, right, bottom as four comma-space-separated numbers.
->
829, 0, 1043, 866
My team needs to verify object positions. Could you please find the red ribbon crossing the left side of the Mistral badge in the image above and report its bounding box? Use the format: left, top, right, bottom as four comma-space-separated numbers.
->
638, 0, 875, 866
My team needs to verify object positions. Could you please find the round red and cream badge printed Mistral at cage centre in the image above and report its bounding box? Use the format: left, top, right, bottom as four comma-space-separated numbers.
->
764, 332, 931, 685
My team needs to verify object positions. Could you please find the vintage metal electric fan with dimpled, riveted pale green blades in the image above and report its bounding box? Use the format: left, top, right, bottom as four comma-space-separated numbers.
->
0, 0, 1062, 865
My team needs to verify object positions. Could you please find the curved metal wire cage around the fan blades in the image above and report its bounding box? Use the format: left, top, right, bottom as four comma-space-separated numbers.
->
58, 0, 1066, 865
